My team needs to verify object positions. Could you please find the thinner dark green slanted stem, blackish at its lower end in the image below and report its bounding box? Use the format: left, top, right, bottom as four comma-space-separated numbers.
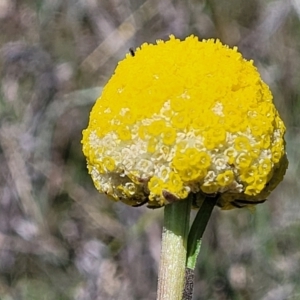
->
182, 196, 218, 300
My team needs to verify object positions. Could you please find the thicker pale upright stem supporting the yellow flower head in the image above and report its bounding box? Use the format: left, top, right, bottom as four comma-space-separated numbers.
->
157, 196, 192, 300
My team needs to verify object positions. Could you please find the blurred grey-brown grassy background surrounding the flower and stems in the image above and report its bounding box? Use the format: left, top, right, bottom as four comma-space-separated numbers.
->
0, 0, 300, 300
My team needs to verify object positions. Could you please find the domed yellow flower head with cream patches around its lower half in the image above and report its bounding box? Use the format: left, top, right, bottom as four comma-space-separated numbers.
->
82, 36, 287, 209
